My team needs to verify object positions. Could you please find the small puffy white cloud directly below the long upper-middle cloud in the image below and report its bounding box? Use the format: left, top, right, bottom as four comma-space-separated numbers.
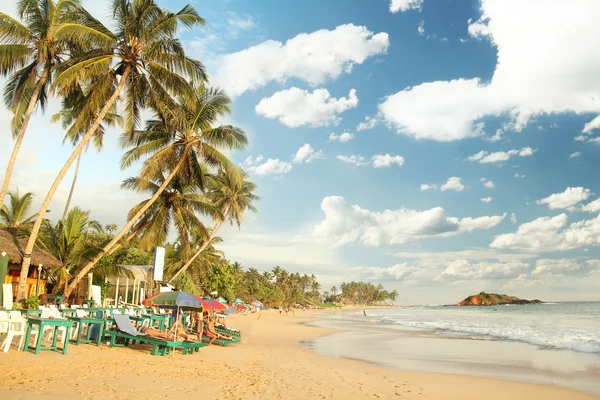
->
256, 87, 358, 128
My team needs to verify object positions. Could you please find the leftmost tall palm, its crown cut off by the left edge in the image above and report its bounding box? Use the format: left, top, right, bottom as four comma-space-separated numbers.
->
0, 0, 80, 204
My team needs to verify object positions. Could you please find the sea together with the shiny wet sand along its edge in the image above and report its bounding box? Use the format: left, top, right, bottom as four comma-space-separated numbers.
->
305, 302, 600, 395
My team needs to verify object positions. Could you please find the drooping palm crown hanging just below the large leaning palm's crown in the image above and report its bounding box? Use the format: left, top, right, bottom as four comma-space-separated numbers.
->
122, 174, 215, 259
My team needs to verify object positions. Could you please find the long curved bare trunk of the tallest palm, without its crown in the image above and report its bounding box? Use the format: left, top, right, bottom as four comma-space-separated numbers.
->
17, 68, 131, 301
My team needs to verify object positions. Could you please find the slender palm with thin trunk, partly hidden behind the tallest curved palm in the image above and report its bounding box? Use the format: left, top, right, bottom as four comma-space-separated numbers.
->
52, 86, 121, 223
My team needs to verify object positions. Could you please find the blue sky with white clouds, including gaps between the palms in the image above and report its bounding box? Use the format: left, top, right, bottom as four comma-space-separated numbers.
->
0, 0, 600, 304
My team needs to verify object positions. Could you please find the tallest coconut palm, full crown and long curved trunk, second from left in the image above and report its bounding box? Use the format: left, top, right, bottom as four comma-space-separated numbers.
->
17, 0, 206, 300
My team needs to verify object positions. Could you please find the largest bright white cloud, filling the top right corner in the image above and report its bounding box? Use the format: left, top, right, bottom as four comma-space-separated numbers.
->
379, 0, 600, 141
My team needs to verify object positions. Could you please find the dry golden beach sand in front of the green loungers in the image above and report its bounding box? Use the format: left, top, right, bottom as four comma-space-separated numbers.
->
0, 311, 598, 400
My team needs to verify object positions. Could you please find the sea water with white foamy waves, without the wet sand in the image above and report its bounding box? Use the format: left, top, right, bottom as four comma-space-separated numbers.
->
372, 303, 600, 354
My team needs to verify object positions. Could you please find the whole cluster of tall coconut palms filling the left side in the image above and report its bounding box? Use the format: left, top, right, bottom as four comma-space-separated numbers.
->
0, 0, 258, 300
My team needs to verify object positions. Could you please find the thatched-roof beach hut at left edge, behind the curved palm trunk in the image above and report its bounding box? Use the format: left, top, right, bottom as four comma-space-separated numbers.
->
0, 230, 61, 298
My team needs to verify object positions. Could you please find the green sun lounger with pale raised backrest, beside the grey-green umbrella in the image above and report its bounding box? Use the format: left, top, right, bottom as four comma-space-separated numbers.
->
104, 314, 205, 356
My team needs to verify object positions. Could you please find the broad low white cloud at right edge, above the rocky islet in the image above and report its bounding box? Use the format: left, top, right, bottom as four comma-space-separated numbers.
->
490, 214, 600, 251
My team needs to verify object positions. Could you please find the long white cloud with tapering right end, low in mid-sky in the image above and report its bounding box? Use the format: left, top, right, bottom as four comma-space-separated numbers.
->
313, 196, 504, 246
